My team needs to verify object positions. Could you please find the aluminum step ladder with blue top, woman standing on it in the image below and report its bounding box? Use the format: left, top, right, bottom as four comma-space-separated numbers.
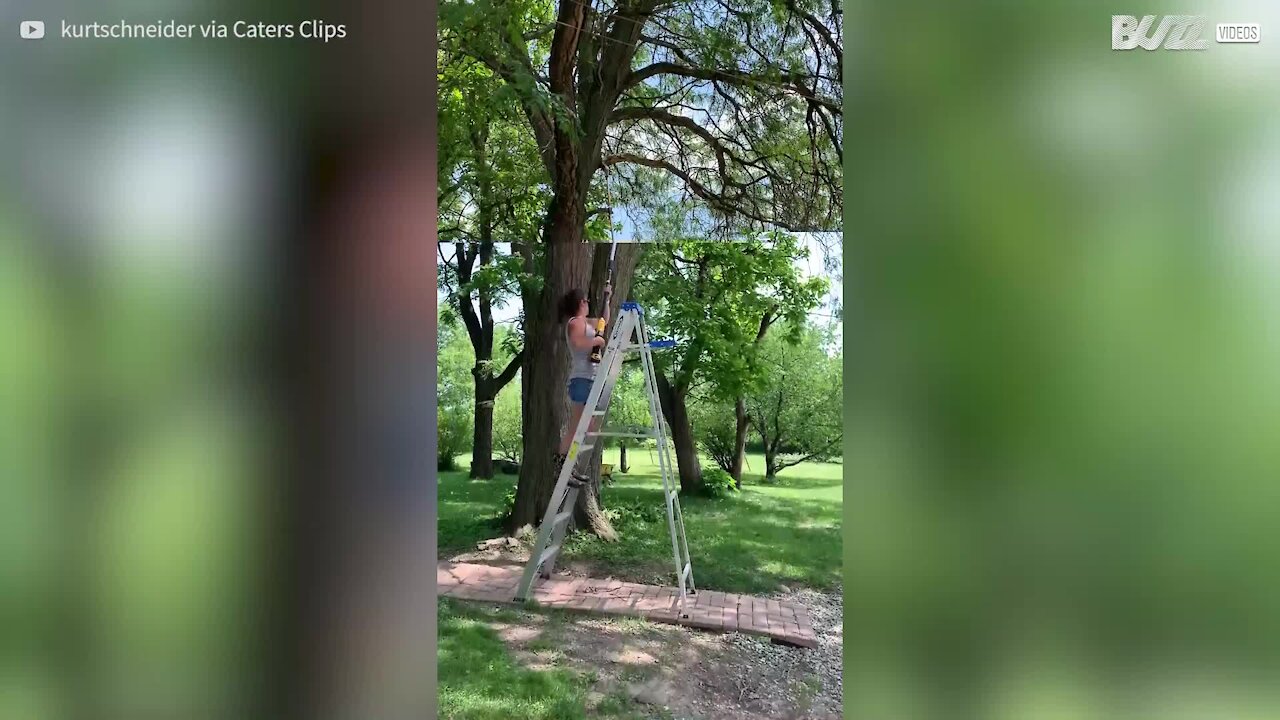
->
516, 302, 698, 614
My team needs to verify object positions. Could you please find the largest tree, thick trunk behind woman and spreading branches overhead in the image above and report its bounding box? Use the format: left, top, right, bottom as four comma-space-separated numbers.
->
440, 0, 842, 529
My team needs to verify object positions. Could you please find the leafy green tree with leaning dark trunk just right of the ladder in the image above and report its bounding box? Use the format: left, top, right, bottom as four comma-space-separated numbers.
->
637, 233, 827, 491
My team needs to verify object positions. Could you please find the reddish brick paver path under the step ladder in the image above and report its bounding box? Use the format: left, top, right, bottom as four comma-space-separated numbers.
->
435, 562, 818, 647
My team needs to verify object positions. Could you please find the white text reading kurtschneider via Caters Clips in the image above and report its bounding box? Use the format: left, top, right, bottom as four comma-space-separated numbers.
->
61, 20, 347, 42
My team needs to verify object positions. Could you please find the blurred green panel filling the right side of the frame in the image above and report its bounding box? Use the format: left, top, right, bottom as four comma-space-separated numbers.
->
845, 0, 1280, 720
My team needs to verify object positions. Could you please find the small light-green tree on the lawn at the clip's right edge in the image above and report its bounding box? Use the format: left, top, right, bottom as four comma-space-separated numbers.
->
745, 327, 844, 482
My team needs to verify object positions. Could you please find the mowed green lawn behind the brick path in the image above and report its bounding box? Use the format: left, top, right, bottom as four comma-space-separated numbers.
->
438, 450, 844, 593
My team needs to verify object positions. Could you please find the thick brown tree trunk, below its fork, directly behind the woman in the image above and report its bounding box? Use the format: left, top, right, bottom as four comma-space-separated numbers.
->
506, 210, 591, 533
